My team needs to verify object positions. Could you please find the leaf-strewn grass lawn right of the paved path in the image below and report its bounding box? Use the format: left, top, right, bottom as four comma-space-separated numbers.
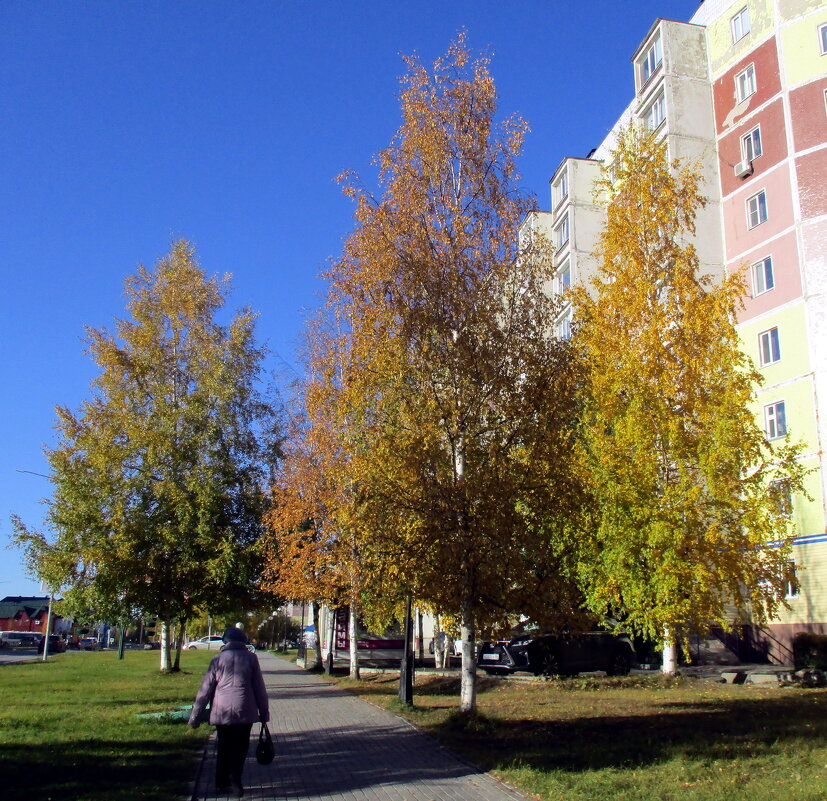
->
338, 674, 827, 801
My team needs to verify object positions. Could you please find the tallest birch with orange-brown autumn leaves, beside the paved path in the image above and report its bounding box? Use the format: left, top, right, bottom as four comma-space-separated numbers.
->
328, 35, 578, 712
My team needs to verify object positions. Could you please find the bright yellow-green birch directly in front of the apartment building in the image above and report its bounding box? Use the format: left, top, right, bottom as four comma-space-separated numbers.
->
574, 127, 802, 671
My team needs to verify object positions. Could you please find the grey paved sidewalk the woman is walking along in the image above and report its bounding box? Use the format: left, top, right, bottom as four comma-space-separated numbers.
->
192, 653, 525, 801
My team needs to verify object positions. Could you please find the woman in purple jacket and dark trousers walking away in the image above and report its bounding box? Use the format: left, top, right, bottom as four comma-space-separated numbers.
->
189, 628, 270, 797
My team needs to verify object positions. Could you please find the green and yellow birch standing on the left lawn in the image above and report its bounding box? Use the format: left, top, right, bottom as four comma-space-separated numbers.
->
12, 241, 277, 670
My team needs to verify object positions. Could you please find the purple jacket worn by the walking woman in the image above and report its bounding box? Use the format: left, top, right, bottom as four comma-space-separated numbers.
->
190, 642, 270, 726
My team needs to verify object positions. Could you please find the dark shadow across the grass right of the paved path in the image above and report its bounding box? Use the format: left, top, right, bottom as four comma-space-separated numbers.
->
429, 694, 827, 772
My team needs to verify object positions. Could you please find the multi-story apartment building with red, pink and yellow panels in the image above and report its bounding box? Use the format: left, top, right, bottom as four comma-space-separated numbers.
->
544, 0, 827, 661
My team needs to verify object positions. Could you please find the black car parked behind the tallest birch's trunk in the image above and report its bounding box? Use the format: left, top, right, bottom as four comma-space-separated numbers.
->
477, 631, 635, 676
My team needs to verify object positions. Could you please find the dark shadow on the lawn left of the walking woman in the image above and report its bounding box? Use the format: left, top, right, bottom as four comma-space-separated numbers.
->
0, 738, 204, 801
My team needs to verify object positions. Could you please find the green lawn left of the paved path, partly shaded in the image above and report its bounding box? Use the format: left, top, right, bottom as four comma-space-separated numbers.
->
0, 651, 215, 801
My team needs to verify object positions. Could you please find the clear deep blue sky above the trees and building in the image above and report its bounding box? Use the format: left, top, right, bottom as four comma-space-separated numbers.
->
0, 0, 699, 597
